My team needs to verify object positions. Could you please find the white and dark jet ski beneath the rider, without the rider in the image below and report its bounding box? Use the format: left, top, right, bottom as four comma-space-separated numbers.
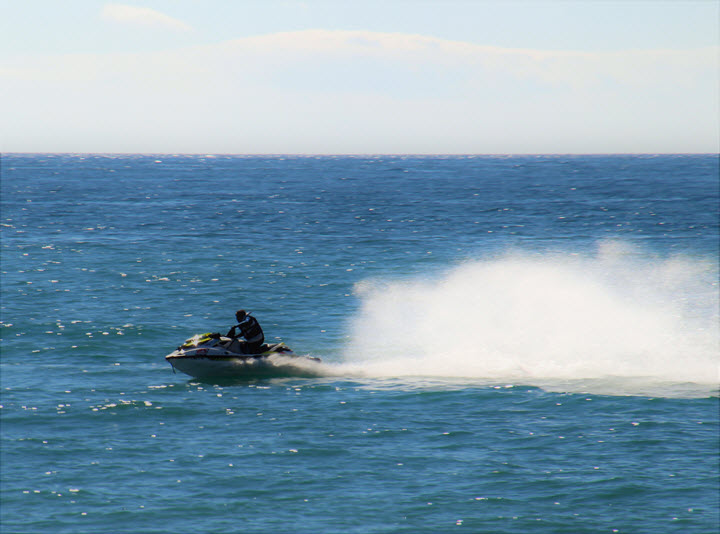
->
165, 332, 320, 379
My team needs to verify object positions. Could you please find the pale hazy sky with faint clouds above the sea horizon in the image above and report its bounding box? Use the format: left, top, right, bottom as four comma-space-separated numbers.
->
0, 0, 720, 154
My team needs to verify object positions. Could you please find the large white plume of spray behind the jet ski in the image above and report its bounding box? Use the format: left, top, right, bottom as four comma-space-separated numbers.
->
345, 242, 720, 394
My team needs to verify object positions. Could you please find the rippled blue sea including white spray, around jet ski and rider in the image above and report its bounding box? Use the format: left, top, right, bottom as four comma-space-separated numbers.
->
0, 154, 720, 534
